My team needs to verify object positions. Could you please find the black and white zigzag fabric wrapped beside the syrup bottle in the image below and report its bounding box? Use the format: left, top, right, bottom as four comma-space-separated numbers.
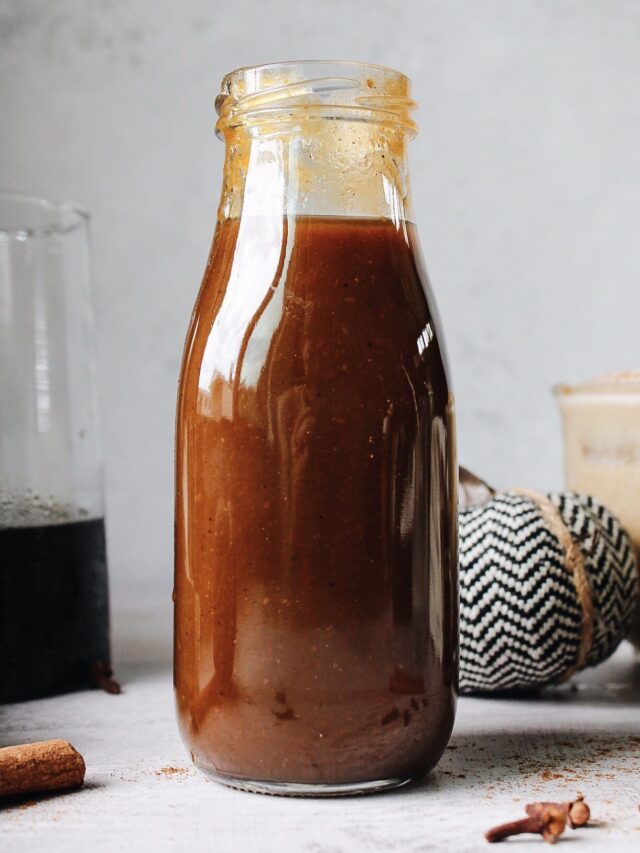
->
460, 492, 638, 693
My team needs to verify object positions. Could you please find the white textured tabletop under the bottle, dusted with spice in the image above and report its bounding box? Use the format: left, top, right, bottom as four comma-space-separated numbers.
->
0, 645, 640, 853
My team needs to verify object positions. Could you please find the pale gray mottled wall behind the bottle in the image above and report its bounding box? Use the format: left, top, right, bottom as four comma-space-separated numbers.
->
0, 0, 640, 657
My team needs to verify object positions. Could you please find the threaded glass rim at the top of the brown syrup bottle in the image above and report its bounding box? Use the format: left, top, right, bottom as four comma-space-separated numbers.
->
216, 60, 417, 136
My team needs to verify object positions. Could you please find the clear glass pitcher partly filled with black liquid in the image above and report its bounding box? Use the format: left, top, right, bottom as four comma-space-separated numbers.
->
0, 193, 109, 702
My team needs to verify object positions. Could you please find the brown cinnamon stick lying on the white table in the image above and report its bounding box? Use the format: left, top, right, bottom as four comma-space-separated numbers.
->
0, 740, 85, 797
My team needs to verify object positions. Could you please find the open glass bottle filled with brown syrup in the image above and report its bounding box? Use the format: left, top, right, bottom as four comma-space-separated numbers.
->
175, 62, 457, 795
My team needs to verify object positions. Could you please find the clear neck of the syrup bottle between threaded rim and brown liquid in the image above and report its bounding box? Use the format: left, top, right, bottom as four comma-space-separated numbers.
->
218, 120, 412, 225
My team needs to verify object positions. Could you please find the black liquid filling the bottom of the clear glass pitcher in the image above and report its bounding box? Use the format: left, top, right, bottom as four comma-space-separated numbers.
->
0, 518, 109, 702
